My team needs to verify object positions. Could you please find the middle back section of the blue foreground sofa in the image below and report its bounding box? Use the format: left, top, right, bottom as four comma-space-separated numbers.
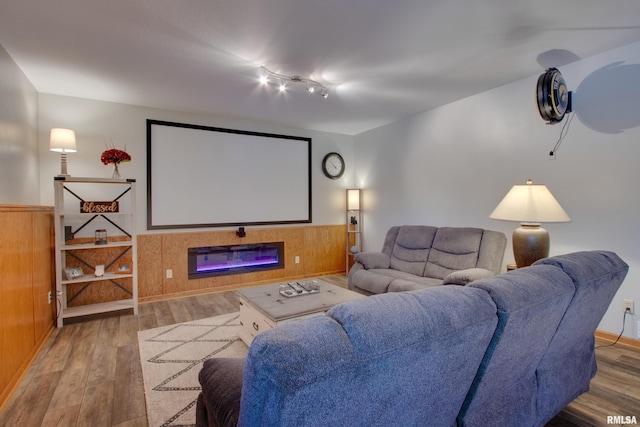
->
458, 265, 575, 427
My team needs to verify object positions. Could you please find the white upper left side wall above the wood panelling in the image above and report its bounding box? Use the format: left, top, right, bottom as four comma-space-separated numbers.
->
0, 45, 40, 205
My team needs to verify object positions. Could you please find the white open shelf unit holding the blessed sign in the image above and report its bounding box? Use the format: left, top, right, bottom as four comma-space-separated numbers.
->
54, 176, 138, 327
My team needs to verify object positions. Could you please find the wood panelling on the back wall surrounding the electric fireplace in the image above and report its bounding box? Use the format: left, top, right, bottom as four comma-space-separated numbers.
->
138, 225, 346, 302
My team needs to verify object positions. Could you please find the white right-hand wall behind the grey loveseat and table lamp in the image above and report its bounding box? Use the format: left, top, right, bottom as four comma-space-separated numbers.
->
355, 43, 640, 338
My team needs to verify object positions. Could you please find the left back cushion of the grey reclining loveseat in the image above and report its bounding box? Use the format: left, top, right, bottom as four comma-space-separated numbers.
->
389, 225, 442, 278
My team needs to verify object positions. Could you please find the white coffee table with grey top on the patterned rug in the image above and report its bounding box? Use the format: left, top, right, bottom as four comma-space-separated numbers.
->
236, 279, 366, 345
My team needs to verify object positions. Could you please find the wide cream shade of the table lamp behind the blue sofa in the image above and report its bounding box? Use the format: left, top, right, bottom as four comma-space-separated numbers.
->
489, 180, 571, 223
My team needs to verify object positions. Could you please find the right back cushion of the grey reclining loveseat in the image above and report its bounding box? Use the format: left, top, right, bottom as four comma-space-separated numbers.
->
420, 227, 483, 279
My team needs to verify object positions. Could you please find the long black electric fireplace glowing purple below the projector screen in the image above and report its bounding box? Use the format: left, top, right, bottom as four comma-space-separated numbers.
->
188, 242, 284, 279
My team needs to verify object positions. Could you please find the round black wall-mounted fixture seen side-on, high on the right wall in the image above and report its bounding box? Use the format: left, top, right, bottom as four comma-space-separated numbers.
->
536, 68, 570, 123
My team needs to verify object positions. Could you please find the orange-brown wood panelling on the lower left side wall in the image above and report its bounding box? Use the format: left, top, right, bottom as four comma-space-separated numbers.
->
0, 205, 55, 408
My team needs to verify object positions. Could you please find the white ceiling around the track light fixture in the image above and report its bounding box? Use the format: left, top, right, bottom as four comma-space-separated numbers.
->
0, 0, 640, 135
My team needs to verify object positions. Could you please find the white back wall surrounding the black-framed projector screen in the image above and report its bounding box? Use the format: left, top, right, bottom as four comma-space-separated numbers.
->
39, 94, 354, 234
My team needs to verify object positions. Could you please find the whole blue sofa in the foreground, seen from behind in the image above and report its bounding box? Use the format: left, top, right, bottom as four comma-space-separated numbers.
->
197, 251, 628, 427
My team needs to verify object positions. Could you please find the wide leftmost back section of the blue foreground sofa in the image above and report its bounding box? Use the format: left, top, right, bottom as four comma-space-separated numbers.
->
239, 286, 497, 427
